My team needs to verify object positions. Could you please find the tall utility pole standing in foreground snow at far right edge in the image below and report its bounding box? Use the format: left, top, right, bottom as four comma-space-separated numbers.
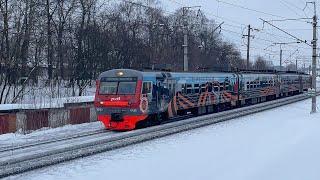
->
307, 2, 317, 113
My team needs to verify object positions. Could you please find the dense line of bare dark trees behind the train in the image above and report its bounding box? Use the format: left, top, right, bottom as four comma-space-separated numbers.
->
0, 0, 270, 104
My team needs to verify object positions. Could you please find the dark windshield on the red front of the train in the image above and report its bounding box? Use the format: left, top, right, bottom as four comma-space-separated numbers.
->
99, 78, 137, 95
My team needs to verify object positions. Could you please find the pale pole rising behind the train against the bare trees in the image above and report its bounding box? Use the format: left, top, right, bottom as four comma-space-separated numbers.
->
182, 6, 201, 71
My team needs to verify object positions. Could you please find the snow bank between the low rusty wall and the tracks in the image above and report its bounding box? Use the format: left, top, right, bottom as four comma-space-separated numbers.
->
0, 121, 104, 148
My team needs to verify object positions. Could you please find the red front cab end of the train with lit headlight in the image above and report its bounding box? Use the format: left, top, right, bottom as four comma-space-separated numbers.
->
94, 69, 151, 130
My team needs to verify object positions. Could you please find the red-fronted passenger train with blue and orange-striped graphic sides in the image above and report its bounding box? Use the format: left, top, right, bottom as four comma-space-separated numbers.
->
94, 69, 311, 131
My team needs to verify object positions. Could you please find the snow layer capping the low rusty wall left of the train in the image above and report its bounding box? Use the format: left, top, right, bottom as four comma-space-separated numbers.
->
0, 96, 94, 111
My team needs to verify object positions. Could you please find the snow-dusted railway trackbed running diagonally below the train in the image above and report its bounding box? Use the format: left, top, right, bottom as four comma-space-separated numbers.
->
0, 93, 319, 177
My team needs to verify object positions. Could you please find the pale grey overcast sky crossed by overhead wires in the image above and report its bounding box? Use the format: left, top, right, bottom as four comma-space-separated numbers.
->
159, 0, 320, 67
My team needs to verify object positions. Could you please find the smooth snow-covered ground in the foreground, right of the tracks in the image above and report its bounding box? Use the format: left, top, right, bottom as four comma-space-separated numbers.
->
5, 98, 320, 180
